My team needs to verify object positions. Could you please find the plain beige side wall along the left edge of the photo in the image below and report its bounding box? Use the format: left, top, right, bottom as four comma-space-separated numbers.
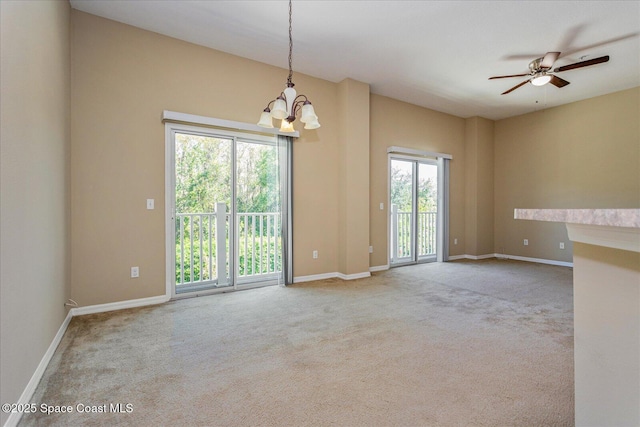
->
0, 1, 70, 424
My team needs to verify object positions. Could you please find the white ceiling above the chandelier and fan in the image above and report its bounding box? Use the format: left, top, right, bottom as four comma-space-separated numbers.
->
71, 0, 640, 120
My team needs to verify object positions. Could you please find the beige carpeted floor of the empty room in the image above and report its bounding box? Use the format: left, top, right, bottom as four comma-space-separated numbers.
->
20, 259, 574, 426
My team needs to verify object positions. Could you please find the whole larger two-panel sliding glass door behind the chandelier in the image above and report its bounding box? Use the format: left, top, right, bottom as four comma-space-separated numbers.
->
167, 125, 290, 297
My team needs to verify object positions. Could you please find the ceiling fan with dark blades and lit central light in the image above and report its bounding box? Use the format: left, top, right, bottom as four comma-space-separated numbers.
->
489, 52, 609, 95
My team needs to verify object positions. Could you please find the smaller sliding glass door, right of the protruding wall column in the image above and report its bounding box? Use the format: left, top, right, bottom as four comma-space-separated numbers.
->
389, 156, 438, 266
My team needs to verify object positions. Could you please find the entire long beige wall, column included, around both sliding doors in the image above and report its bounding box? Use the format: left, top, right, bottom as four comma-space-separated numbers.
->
71, 11, 472, 305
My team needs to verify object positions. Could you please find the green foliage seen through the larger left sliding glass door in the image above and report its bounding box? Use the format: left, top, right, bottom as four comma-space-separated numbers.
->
175, 134, 282, 284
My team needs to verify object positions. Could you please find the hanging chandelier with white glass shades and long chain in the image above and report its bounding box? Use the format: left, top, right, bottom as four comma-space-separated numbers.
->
258, 0, 320, 132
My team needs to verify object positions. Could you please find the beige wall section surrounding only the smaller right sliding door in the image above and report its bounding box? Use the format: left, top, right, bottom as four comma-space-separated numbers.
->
369, 94, 465, 267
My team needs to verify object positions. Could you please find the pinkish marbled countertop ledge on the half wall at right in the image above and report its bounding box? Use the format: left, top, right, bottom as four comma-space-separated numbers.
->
514, 209, 640, 228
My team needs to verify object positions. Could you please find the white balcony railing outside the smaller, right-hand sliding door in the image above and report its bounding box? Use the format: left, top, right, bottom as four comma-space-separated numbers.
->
390, 205, 437, 262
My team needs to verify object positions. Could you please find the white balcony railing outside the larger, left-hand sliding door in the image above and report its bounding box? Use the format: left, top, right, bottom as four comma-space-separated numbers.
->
175, 203, 282, 289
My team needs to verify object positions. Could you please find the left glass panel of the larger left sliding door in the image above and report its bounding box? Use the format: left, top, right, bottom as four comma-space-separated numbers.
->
170, 131, 234, 294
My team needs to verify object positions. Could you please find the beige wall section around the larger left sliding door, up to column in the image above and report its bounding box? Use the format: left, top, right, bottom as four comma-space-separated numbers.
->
71, 11, 341, 306
